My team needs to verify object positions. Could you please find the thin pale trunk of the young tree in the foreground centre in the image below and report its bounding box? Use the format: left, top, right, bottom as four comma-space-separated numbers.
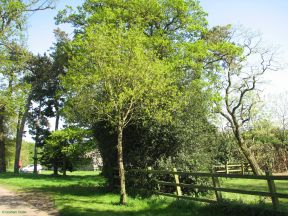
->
117, 122, 127, 205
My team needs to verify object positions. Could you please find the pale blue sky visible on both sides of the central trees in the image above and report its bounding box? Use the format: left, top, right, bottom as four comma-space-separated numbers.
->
28, 0, 288, 93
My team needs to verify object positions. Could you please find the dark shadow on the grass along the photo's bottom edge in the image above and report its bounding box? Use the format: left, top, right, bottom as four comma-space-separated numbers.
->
61, 200, 287, 216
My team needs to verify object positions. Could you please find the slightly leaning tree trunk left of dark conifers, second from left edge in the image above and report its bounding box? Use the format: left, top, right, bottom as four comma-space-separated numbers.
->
14, 94, 32, 173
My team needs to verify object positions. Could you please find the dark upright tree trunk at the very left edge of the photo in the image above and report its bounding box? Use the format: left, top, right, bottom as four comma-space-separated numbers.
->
0, 107, 6, 173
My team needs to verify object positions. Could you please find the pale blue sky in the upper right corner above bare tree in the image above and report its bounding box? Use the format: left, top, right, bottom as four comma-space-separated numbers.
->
200, 0, 288, 45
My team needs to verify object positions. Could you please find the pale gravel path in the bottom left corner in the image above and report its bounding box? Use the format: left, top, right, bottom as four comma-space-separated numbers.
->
0, 187, 58, 216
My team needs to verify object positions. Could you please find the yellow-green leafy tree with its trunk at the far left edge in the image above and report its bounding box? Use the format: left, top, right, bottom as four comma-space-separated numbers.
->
0, 43, 28, 172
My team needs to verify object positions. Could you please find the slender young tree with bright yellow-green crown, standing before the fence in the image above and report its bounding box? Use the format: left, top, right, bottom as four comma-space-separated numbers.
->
65, 26, 181, 204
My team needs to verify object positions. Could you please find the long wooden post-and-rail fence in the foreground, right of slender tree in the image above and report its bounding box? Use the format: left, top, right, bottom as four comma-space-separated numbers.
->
124, 168, 288, 210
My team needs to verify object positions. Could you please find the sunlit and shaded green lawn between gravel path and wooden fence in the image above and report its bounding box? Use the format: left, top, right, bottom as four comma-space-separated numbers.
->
0, 172, 287, 216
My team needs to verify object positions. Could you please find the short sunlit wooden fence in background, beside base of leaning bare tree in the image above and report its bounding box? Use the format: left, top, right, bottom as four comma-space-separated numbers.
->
212, 163, 252, 175
